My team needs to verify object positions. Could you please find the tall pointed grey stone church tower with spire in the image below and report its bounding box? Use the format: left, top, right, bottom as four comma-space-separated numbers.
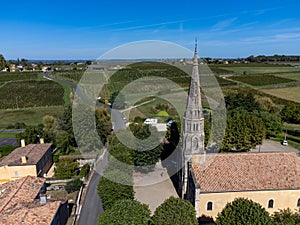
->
182, 41, 205, 196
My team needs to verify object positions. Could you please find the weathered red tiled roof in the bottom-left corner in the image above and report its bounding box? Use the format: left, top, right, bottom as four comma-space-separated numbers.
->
0, 176, 65, 225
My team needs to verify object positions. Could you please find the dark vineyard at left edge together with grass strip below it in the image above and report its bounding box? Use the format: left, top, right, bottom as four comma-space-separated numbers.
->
0, 72, 66, 128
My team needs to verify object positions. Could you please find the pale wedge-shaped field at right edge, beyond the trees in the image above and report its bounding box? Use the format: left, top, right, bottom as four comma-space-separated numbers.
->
262, 87, 300, 103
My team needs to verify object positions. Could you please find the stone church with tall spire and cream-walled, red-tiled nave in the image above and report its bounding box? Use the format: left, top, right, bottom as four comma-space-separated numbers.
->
179, 41, 300, 219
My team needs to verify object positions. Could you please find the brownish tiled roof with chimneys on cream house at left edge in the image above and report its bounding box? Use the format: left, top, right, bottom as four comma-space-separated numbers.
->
0, 144, 52, 166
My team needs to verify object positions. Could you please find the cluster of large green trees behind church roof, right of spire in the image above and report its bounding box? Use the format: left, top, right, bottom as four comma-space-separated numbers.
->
204, 93, 283, 152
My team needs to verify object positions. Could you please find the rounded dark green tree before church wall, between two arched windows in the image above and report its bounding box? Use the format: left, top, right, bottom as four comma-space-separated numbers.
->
216, 198, 272, 225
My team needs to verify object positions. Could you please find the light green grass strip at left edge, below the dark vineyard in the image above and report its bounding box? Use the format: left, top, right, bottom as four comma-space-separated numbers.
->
0, 106, 64, 128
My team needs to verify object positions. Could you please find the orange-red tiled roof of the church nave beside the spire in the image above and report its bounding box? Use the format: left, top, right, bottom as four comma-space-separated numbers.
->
192, 152, 300, 192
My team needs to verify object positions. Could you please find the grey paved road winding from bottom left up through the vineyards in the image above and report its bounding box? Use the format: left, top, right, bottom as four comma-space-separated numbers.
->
44, 72, 126, 225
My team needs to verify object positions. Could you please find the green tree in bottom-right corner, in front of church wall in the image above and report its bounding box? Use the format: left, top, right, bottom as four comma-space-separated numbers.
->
272, 208, 300, 225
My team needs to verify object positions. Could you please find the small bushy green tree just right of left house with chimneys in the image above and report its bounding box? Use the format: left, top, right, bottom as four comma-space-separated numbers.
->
54, 158, 79, 179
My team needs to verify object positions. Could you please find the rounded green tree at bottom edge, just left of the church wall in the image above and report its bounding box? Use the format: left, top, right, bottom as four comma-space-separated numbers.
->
152, 197, 198, 225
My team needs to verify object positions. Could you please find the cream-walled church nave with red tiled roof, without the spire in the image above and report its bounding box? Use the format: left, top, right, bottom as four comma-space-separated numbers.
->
186, 152, 300, 218
